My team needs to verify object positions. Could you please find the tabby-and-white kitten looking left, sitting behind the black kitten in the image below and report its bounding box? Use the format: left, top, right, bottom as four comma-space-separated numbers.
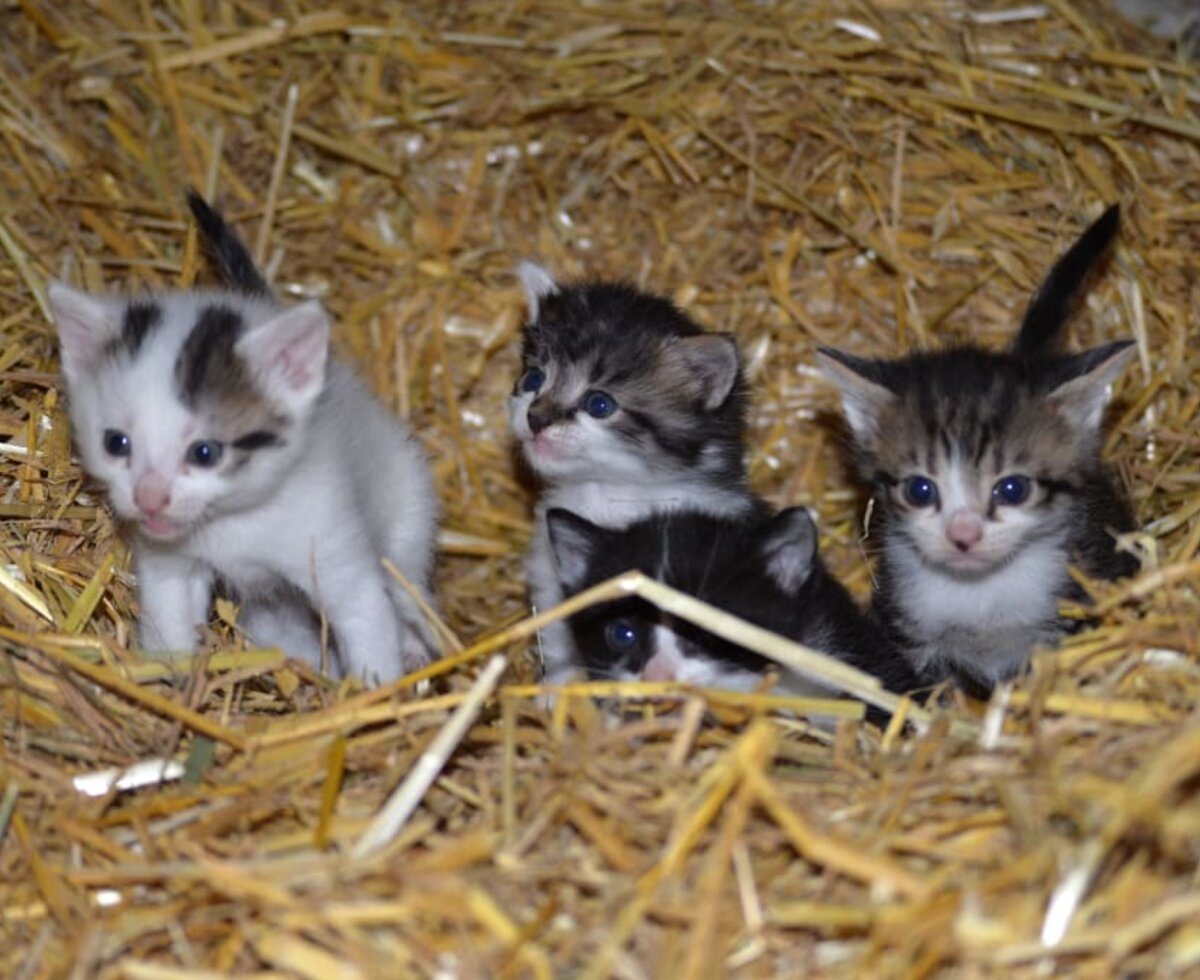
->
509, 263, 754, 684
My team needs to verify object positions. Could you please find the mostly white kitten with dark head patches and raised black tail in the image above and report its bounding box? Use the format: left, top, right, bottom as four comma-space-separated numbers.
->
49, 194, 437, 680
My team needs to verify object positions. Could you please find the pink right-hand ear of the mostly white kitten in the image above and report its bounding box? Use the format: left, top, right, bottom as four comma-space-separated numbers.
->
234, 300, 330, 411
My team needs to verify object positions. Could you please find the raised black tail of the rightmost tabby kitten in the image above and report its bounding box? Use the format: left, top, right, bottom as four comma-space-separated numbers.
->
1013, 204, 1121, 357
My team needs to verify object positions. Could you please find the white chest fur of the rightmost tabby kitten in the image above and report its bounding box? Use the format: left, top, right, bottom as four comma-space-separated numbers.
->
876, 530, 1070, 683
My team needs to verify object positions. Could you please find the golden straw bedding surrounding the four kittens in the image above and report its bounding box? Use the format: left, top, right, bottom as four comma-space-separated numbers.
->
0, 0, 1200, 980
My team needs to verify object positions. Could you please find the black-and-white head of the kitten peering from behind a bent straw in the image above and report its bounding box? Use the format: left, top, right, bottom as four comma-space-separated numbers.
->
546, 507, 826, 691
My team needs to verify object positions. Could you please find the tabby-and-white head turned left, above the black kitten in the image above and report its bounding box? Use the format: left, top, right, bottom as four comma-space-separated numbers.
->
509, 263, 743, 481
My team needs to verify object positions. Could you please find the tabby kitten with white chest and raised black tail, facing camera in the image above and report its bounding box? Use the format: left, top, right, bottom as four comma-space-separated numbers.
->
818, 208, 1138, 693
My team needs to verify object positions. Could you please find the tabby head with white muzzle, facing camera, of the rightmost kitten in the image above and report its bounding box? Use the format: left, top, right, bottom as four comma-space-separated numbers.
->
818, 341, 1134, 578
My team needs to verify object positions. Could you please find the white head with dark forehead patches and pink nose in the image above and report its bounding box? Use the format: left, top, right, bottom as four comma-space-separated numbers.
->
49, 283, 330, 541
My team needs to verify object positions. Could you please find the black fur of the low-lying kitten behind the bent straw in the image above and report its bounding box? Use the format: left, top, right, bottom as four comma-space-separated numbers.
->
547, 503, 920, 721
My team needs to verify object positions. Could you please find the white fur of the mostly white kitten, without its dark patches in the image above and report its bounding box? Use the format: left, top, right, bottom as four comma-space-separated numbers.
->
50, 285, 437, 680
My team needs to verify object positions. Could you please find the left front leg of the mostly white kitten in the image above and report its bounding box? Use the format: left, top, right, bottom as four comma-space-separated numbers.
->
134, 542, 212, 653
